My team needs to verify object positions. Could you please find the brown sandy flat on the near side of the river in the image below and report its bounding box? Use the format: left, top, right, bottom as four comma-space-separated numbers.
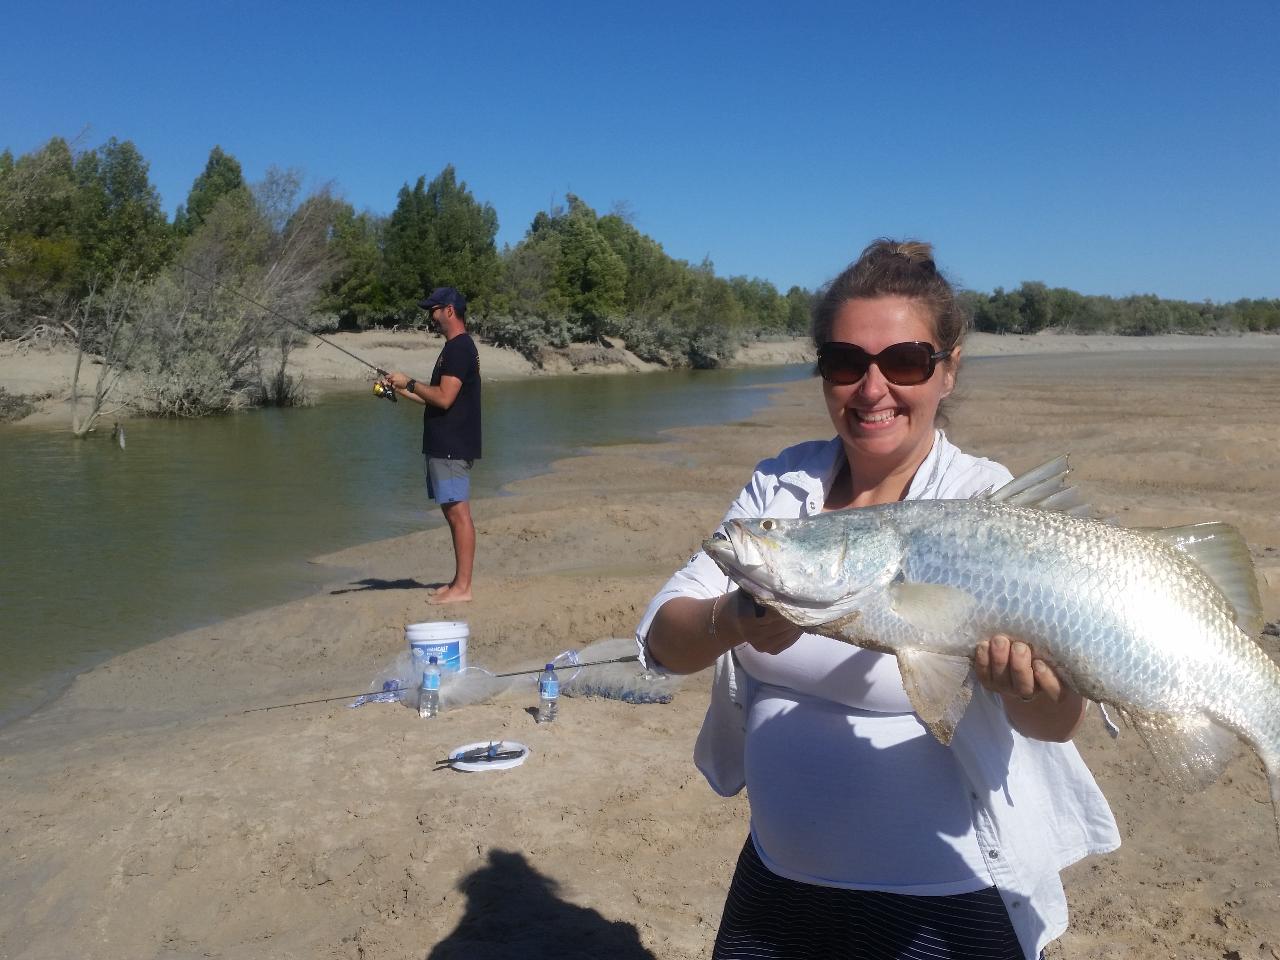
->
0, 338, 1280, 960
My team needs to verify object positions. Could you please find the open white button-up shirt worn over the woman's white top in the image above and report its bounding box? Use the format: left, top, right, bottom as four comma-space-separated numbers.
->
636, 430, 1120, 960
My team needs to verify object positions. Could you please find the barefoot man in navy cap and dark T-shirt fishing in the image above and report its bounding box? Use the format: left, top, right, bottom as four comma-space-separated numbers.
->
383, 287, 480, 603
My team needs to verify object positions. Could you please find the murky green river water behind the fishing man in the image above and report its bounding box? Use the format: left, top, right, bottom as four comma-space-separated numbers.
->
0, 365, 812, 724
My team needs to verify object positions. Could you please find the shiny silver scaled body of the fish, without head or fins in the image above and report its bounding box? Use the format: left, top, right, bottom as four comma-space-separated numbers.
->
869, 500, 1270, 716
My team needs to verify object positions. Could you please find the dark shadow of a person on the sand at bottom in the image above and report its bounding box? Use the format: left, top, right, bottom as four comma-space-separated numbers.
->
426, 850, 655, 960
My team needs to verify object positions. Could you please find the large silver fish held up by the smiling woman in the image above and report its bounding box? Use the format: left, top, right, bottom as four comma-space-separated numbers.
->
703, 457, 1280, 829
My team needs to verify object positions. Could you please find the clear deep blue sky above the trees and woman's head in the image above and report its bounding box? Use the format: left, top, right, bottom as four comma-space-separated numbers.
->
0, 0, 1280, 301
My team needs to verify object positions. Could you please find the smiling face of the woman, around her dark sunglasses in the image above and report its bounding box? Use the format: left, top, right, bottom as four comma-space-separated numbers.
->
822, 297, 959, 470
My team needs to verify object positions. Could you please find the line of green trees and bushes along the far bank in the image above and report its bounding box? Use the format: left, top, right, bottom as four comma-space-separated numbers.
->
0, 137, 1280, 424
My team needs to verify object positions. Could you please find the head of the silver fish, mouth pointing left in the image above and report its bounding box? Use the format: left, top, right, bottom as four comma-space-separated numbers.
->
703, 509, 904, 626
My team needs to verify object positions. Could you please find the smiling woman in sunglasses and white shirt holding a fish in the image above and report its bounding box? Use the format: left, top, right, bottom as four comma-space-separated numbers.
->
636, 241, 1119, 960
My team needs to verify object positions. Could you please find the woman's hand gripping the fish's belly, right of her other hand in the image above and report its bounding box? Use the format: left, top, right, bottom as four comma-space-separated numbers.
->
973, 634, 1085, 741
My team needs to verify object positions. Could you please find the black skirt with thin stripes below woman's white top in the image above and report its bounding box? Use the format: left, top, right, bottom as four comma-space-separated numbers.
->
712, 837, 1023, 960
